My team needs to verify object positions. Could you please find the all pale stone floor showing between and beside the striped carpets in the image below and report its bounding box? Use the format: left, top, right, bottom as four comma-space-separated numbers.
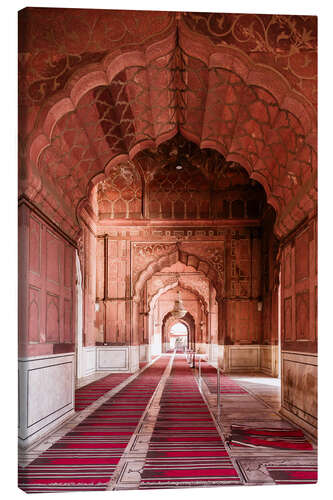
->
19, 355, 317, 490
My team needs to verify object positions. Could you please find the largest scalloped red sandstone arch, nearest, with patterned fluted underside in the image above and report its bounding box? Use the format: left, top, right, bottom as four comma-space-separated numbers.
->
24, 24, 316, 239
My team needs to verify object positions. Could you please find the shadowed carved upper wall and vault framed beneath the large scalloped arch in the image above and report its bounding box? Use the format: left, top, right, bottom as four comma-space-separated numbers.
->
92, 134, 265, 221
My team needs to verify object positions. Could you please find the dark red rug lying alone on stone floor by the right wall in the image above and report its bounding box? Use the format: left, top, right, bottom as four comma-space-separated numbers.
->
229, 425, 313, 450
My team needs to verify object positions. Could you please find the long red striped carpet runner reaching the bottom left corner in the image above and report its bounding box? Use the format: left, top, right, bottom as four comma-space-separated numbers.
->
19, 356, 169, 493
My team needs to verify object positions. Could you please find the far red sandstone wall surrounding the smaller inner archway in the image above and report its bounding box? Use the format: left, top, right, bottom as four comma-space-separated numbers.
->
92, 228, 263, 345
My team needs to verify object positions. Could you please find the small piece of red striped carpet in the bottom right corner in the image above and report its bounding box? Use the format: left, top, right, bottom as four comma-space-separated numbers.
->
266, 465, 318, 484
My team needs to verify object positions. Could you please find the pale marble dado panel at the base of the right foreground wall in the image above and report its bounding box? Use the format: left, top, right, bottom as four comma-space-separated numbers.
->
281, 351, 317, 435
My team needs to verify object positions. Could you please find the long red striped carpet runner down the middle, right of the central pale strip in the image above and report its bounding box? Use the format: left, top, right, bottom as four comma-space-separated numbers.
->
139, 355, 241, 489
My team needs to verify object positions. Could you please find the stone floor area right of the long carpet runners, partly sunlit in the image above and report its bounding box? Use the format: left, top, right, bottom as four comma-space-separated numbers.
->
197, 373, 317, 485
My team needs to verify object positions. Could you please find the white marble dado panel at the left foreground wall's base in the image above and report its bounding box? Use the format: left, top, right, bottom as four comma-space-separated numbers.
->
18, 353, 75, 448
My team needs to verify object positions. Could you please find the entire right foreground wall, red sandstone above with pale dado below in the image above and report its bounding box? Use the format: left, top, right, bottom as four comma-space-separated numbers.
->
281, 219, 318, 435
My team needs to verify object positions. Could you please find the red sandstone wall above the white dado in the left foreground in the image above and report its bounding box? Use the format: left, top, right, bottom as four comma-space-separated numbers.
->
19, 204, 75, 356
